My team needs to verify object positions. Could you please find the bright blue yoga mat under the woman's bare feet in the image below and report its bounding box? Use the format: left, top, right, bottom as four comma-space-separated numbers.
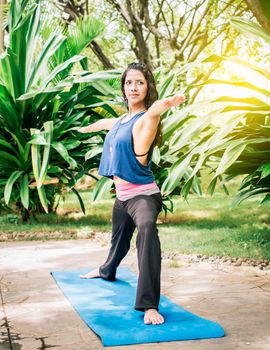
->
52, 267, 224, 346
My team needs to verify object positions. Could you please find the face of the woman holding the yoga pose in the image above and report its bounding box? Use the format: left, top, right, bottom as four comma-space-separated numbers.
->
124, 69, 147, 106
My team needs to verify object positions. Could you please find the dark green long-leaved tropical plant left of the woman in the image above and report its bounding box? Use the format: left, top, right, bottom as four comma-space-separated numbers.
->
0, 0, 119, 219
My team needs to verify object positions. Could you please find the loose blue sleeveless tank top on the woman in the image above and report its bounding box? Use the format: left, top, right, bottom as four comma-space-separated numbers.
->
98, 112, 154, 184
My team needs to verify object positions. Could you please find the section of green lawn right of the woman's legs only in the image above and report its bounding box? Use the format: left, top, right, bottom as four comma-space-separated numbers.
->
159, 194, 270, 260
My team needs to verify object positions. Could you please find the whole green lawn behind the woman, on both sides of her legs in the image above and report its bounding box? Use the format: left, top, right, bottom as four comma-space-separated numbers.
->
0, 187, 270, 260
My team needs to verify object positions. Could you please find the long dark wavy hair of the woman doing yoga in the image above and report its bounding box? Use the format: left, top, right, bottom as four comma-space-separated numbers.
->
121, 62, 162, 145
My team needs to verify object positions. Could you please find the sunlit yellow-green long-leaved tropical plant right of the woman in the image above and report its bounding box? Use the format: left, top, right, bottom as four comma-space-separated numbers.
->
158, 15, 270, 204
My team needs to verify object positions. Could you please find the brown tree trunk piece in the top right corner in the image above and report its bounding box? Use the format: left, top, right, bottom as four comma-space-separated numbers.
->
245, 0, 270, 34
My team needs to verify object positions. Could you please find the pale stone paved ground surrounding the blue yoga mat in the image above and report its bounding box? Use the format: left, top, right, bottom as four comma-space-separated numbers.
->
0, 240, 270, 350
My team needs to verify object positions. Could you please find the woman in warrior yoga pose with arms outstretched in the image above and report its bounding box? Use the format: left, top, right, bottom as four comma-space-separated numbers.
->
79, 63, 185, 324
